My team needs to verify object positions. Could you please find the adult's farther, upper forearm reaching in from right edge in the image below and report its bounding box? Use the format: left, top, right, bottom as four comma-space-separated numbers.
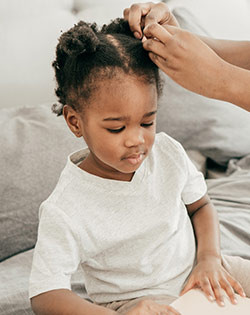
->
199, 36, 250, 70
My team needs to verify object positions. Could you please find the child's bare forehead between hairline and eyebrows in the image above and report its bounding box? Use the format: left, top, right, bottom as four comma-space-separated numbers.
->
88, 75, 157, 116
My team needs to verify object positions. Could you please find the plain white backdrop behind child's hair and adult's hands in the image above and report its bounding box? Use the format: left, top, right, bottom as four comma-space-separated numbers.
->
0, 0, 250, 107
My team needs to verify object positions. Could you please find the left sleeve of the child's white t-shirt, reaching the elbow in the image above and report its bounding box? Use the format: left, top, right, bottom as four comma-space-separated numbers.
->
29, 203, 80, 298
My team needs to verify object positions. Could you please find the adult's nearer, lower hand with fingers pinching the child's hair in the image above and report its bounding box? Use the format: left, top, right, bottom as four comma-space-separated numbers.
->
143, 23, 229, 98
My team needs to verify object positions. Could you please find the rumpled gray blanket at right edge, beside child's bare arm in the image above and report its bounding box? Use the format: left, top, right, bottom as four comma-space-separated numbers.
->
207, 155, 250, 259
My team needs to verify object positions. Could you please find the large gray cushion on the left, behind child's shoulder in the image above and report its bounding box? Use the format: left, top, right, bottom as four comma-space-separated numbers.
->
0, 104, 84, 261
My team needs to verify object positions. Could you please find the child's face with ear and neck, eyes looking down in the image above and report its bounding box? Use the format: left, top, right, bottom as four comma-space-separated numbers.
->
64, 75, 157, 181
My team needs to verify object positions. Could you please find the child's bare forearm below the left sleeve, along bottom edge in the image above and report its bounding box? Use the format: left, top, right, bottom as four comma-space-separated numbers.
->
31, 289, 117, 315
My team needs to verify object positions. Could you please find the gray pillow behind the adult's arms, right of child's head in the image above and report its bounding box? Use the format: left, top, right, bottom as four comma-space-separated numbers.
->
158, 7, 250, 165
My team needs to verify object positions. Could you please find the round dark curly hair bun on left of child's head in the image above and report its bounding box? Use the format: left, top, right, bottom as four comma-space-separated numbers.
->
59, 21, 99, 56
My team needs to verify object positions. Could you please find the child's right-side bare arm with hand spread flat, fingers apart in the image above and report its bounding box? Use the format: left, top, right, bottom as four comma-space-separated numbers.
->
185, 195, 245, 306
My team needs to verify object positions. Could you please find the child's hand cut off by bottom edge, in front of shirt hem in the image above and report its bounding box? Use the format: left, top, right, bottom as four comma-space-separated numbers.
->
125, 300, 181, 315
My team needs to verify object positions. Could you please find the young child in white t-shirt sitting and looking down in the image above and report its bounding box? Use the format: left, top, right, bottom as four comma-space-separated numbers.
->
30, 19, 248, 315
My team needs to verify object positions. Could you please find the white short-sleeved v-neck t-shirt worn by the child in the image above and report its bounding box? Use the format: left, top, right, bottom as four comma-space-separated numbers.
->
29, 133, 206, 303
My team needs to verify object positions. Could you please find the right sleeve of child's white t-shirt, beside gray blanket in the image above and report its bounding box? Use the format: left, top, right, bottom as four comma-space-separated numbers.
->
181, 147, 207, 205
